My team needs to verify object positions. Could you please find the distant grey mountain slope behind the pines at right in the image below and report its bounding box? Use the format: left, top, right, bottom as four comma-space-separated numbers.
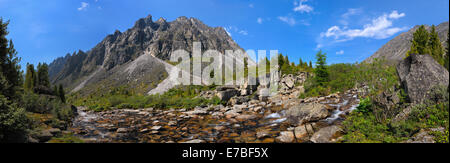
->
365, 22, 449, 63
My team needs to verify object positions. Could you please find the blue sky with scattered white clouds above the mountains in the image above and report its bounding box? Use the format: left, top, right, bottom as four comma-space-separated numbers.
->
0, 0, 449, 67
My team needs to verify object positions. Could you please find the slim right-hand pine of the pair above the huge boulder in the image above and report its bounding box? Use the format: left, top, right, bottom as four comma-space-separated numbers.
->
429, 25, 445, 65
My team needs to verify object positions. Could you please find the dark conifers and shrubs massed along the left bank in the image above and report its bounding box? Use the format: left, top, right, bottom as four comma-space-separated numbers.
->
0, 18, 74, 142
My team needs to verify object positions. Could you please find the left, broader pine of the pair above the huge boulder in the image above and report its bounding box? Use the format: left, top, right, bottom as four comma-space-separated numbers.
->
406, 25, 431, 56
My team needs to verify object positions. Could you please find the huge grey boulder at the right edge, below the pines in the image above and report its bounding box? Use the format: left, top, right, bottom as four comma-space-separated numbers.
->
397, 54, 449, 103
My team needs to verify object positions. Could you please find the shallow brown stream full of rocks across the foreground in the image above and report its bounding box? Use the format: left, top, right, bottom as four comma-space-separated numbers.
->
69, 87, 359, 143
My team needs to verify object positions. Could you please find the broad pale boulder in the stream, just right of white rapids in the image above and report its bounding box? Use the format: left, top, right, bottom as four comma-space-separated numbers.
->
286, 103, 330, 125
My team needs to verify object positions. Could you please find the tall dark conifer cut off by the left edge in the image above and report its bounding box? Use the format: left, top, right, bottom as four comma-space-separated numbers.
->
0, 18, 29, 142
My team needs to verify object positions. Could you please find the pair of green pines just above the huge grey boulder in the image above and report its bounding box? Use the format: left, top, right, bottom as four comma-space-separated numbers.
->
406, 25, 448, 66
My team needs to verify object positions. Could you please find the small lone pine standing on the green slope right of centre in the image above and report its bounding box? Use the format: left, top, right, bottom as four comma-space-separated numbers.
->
314, 50, 329, 86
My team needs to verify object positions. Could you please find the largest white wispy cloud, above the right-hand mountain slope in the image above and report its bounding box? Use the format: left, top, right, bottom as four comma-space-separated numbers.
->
320, 11, 408, 42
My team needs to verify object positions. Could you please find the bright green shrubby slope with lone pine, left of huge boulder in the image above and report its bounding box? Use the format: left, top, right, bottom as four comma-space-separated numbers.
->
300, 55, 398, 98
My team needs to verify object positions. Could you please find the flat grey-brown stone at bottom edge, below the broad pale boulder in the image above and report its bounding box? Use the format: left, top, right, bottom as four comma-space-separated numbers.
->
310, 125, 342, 143
